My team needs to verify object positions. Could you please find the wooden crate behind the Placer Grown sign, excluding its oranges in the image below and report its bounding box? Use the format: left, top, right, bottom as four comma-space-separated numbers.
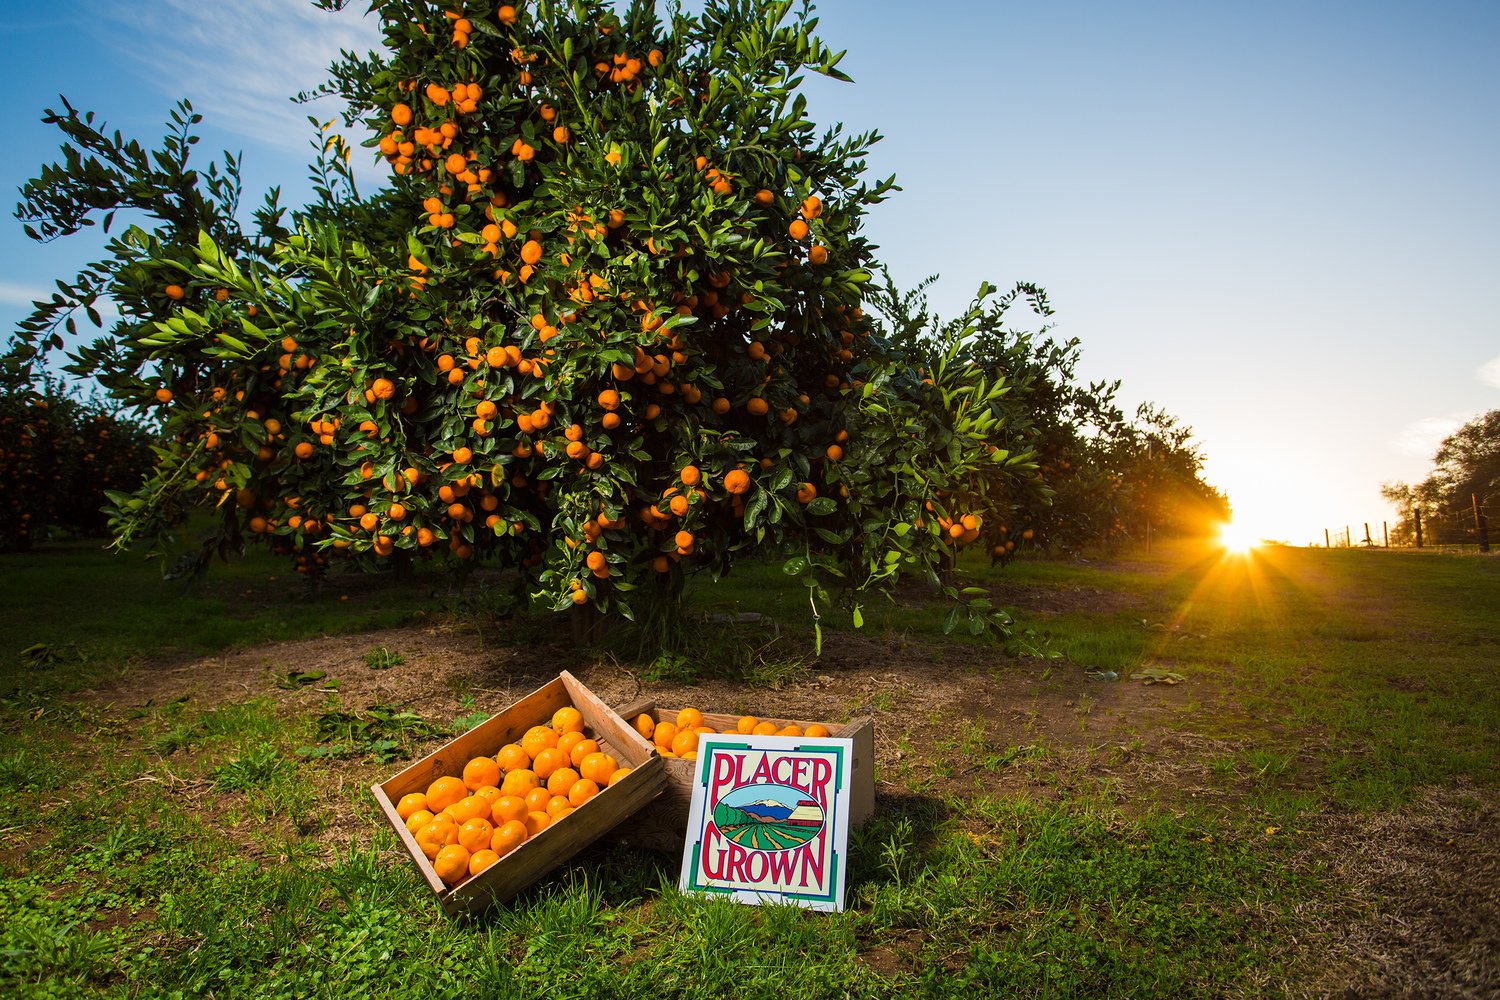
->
612, 699, 875, 855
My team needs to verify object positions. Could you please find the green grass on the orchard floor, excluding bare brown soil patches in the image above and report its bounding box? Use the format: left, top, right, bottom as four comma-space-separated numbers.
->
0, 536, 1500, 999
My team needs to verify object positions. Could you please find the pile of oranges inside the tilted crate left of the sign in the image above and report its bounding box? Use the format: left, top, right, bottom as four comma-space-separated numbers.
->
396, 705, 632, 886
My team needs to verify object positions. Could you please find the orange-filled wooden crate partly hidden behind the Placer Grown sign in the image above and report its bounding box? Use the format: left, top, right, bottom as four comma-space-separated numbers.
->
614, 700, 875, 853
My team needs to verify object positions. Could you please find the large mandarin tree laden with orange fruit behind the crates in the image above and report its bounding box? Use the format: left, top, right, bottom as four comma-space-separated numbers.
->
14, 0, 1028, 641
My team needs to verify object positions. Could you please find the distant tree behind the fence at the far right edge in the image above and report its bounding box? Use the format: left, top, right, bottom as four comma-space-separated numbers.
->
1380, 409, 1500, 544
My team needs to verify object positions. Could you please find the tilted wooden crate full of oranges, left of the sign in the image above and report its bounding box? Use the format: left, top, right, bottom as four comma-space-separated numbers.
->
371, 672, 666, 913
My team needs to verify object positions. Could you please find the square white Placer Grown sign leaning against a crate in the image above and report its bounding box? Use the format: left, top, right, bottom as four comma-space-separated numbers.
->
678, 733, 854, 910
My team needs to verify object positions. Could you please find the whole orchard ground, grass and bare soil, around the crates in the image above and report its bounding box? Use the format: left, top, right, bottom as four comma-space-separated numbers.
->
0, 546, 1500, 997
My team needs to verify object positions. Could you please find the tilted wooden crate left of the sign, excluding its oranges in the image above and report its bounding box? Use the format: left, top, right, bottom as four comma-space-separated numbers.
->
371, 670, 666, 916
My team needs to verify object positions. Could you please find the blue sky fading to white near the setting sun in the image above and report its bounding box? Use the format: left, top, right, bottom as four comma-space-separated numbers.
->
0, 0, 1500, 543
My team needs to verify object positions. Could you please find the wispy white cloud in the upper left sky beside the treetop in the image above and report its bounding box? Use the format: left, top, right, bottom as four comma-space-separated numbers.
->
93, 0, 381, 150
